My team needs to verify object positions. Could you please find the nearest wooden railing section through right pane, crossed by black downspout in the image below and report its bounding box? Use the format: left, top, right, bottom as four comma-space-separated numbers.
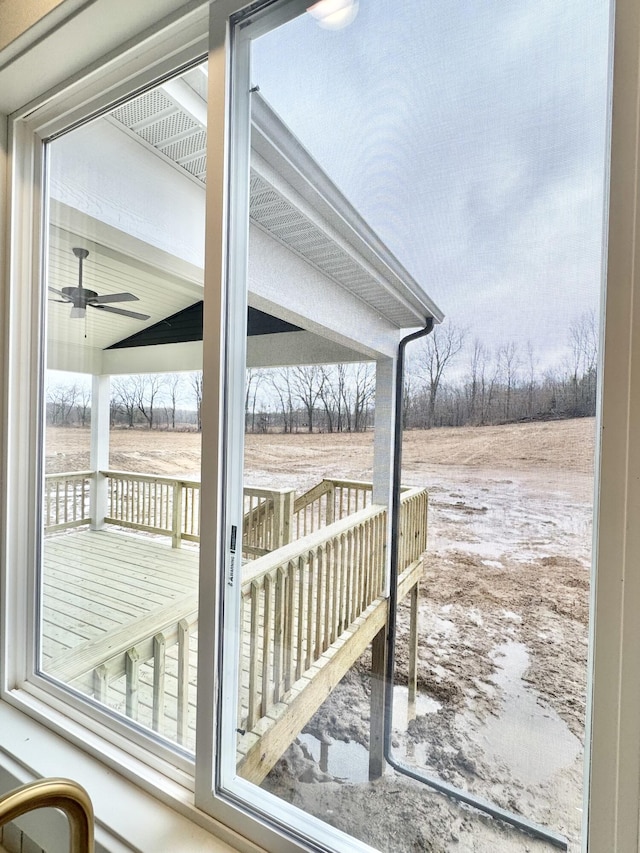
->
240, 489, 428, 730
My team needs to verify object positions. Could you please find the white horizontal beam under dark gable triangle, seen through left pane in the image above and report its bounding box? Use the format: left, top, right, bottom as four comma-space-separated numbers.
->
100, 341, 202, 376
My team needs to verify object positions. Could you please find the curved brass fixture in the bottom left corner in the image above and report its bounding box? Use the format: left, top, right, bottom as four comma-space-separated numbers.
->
0, 779, 94, 853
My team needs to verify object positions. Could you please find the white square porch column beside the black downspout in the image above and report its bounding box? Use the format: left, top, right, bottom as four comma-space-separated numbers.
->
373, 358, 396, 588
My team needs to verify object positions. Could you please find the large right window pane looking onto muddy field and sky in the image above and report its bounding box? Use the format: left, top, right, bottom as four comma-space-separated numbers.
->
224, 2, 609, 851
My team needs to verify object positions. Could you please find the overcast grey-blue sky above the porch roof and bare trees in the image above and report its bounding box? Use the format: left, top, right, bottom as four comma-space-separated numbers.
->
253, 0, 609, 366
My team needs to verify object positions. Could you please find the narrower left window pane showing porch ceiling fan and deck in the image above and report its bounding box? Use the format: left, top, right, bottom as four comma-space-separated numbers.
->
39, 61, 206, 751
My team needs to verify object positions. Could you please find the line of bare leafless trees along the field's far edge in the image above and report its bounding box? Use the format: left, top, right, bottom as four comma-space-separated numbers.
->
47, 312, 598, 433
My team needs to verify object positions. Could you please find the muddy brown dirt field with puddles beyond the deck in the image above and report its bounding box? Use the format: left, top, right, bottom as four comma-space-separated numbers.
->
47, 419, 595, 853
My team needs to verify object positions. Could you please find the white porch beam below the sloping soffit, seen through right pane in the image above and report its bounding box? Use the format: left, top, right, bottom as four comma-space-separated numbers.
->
248, 224, 399, 360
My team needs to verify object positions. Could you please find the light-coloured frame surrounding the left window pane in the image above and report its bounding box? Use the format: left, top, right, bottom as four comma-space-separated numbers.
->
0, 0, 320, 853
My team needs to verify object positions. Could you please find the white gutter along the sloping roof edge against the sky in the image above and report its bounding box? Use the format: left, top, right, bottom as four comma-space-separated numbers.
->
251, 93, 444, 325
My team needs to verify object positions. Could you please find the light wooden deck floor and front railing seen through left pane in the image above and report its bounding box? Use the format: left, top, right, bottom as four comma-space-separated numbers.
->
42, 528, 198, 750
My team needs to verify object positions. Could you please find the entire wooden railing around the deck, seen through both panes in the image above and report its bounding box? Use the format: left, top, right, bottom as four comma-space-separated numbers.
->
43, 480, 428, 746
